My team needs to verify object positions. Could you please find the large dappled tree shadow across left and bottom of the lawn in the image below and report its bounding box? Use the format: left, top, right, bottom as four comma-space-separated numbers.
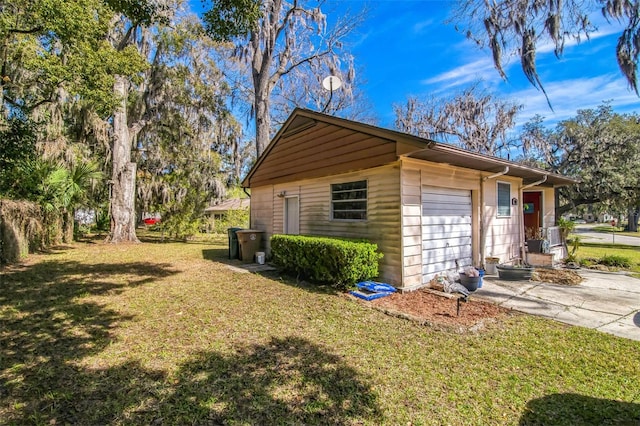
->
0, 255, 382, 425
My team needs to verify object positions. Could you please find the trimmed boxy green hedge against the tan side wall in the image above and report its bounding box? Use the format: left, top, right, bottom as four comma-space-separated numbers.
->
271, 235, 382, 289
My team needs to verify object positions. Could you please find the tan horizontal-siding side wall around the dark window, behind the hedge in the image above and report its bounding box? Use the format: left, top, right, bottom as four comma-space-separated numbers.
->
251, 164, 401, 286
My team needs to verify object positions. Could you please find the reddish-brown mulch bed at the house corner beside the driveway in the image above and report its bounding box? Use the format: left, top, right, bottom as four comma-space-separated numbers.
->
363, 289, 512, 332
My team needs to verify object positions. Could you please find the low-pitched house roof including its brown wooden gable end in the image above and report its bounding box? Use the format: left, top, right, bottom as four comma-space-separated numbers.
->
242, 108, 577, 188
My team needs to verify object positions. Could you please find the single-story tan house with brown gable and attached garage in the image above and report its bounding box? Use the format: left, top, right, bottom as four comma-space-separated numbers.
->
242, 109, 575, 290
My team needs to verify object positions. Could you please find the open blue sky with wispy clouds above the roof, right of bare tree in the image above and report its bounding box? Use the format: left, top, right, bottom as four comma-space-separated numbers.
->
325, 0, 640, 127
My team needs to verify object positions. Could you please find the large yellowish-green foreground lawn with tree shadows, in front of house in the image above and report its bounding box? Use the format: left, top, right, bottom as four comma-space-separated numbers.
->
0, 237, 640, 425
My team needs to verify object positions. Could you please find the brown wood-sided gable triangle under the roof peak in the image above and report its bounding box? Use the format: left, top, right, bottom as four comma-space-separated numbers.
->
245, 123, 396, 187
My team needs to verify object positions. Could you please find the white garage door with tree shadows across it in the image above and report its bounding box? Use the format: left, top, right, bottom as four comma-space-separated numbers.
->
422, 186, 472, 283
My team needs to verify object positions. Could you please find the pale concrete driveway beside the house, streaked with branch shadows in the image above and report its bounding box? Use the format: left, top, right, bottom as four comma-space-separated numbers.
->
472, 270, 640, 341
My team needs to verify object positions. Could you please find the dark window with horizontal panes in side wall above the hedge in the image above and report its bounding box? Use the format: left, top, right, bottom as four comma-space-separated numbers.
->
331, 180, 367, 220
